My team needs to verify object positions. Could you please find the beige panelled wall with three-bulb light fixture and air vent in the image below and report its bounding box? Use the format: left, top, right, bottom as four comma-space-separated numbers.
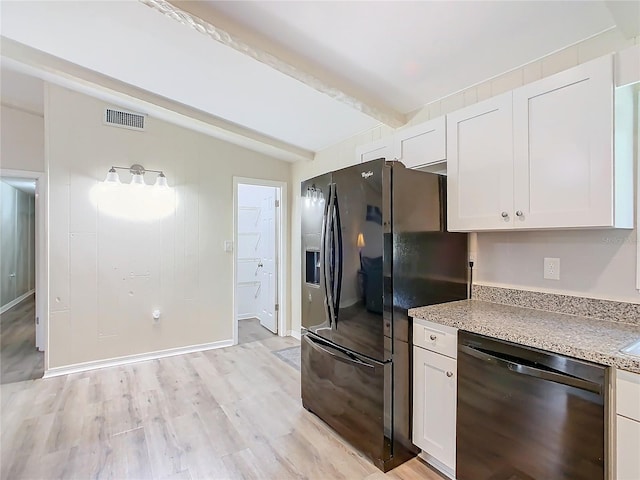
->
45, 85, 291, 368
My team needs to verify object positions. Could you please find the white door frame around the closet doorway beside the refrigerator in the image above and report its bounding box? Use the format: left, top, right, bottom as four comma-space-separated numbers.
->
232, 176, 290, 345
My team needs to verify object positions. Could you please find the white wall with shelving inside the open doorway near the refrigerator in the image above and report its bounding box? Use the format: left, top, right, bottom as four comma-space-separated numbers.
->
236, 184, 275, 319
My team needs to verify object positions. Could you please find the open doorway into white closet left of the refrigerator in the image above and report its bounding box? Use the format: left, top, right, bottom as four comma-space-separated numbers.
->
233, 178, 286, 344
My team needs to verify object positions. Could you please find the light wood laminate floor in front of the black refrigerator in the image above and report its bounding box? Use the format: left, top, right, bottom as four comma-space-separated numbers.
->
0, 337, 442, 480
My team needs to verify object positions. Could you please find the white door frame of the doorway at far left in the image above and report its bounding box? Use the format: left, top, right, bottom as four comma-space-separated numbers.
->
0, 168, 49, 364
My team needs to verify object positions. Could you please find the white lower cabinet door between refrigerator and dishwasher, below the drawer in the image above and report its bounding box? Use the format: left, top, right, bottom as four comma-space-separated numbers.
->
413, 347, 456, 471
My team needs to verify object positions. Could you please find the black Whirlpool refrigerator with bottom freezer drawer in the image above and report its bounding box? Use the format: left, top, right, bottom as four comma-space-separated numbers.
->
301, 159, 467, 471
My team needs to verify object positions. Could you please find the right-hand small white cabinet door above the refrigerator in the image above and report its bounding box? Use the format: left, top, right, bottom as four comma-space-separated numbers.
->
394, 116, 447, 168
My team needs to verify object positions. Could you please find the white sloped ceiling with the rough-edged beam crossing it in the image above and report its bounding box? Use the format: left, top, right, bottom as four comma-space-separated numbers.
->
0, 0, 637, 159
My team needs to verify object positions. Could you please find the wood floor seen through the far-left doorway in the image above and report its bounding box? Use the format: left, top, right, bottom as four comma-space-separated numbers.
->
0, 295, 44, 383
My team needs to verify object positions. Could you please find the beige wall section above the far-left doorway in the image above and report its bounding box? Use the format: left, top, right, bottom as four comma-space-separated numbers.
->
0, 105, 44, 172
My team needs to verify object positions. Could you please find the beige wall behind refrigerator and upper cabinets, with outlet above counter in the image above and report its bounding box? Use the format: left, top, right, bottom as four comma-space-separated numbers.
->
291, 30, 640, 338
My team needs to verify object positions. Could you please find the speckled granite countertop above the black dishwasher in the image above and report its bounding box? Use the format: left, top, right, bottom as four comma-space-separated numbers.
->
409, 300, 640, 373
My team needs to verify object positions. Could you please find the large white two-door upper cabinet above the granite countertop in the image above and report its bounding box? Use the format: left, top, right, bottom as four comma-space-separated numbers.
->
447, 55, 633, 231
